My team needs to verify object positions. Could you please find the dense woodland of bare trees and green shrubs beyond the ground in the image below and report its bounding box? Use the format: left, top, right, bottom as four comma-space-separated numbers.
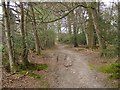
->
0, 2, 120, 85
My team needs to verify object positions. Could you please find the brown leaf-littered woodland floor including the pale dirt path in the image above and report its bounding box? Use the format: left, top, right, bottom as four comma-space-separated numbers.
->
2, 44, 117, 88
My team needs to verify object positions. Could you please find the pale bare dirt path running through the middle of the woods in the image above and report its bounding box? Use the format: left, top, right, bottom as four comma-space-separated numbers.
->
49, 45, 105, 88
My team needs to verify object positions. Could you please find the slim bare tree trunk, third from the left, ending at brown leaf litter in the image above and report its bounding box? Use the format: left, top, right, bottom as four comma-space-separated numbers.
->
30, 3, 40, 54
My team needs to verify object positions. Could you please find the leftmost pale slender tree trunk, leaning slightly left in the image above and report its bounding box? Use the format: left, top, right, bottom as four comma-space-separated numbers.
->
2, 2, 16, 73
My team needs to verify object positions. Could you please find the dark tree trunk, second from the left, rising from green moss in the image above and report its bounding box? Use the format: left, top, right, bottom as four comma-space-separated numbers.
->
20, 2, 29, 67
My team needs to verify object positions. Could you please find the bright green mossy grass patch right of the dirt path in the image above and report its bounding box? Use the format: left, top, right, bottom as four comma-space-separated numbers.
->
97, 63, 120, 79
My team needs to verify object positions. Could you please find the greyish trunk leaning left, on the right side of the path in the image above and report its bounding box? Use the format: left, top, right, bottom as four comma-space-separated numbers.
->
91, 3, 106, 56
